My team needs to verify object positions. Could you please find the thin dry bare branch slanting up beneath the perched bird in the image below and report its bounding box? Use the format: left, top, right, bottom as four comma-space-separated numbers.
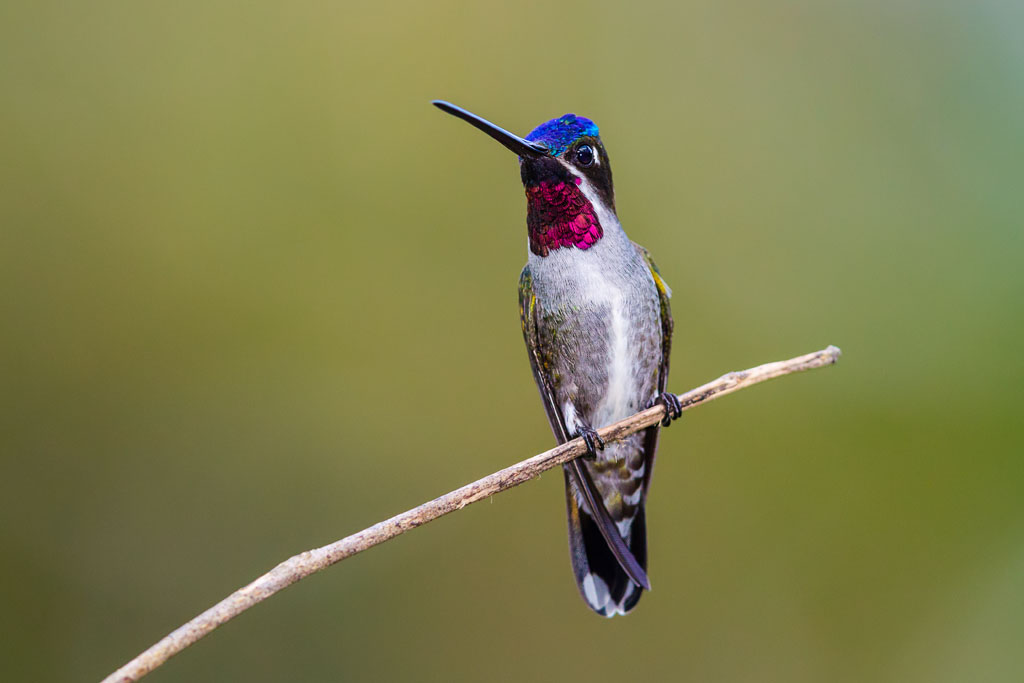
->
103, 346, 840, 683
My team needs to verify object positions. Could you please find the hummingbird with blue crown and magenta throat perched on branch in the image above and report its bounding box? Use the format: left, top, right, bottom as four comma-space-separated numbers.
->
433, 100, 682, 616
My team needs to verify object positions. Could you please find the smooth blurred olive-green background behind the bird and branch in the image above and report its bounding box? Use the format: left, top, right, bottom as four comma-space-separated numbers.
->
0, 0, 1024, 683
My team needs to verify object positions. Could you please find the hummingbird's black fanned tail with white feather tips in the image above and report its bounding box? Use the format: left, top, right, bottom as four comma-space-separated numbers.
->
565, 472, 647, 616
